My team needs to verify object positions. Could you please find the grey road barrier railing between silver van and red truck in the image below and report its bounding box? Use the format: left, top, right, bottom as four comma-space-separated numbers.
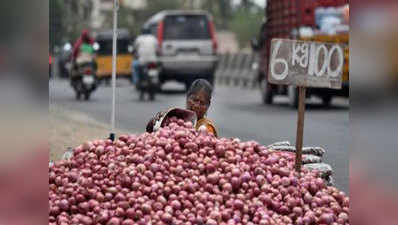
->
215, 53, 258, 88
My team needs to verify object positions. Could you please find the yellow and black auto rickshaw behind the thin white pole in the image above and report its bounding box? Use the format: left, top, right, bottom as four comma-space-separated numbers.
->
94, 29, 133, 83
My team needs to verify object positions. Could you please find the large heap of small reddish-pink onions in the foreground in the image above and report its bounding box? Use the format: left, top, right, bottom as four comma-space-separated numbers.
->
49, 118, 349, 225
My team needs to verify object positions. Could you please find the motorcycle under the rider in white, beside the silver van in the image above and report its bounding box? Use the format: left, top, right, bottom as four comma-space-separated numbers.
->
137, 62, 160, 101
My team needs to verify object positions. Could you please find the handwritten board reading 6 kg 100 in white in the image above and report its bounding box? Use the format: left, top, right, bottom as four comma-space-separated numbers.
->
268, 39, 344, 89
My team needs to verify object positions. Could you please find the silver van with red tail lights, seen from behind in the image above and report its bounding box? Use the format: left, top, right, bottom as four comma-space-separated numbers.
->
144, 10, 218, 87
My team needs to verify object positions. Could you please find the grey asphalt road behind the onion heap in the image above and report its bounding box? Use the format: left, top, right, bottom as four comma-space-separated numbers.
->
49, 80, 350, 193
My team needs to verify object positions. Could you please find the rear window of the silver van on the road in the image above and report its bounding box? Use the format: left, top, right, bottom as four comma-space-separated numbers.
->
164, 15, 210, 40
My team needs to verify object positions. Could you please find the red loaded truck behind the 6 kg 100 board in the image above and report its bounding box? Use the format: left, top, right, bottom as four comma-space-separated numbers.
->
252, 0, 349, 108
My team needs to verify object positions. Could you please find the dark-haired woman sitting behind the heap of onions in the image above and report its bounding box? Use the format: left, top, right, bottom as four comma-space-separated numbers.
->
146, 79, 217, 137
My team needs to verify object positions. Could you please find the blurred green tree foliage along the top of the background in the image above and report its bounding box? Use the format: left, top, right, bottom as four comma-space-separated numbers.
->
50, 0, 264, 50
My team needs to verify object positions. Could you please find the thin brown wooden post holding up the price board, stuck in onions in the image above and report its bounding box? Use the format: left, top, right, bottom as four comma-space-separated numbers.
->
295, 87, 305, 174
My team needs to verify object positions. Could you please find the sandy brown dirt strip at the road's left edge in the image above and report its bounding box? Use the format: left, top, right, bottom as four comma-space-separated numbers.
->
49, 104, 137, 160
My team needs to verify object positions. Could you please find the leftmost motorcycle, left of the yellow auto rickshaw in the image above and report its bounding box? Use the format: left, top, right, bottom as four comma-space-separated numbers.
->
71, 54, 98, 100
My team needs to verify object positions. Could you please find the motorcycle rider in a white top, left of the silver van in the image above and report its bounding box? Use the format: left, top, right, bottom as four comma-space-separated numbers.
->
132, 27, 158, 84
